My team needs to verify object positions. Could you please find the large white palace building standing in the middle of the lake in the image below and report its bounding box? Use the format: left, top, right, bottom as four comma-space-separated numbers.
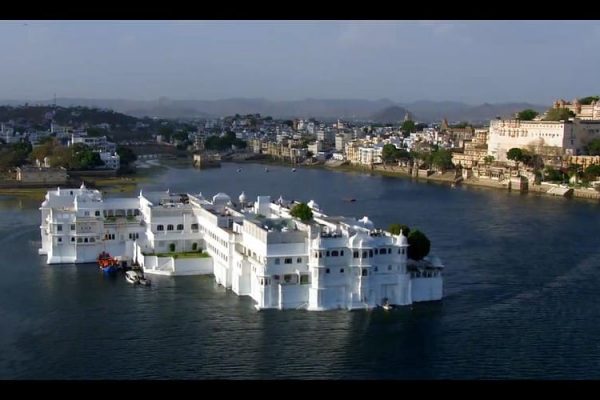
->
39, 185, 443, 310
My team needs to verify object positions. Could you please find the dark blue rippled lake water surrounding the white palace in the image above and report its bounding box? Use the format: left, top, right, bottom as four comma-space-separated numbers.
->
0, 164, 600, 379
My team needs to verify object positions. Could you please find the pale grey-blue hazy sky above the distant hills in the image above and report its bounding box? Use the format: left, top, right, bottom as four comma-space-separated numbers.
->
0, 21, 600, 104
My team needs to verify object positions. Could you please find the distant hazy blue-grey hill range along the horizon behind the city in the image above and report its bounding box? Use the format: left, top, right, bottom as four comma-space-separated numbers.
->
0, 97, 549, 122
